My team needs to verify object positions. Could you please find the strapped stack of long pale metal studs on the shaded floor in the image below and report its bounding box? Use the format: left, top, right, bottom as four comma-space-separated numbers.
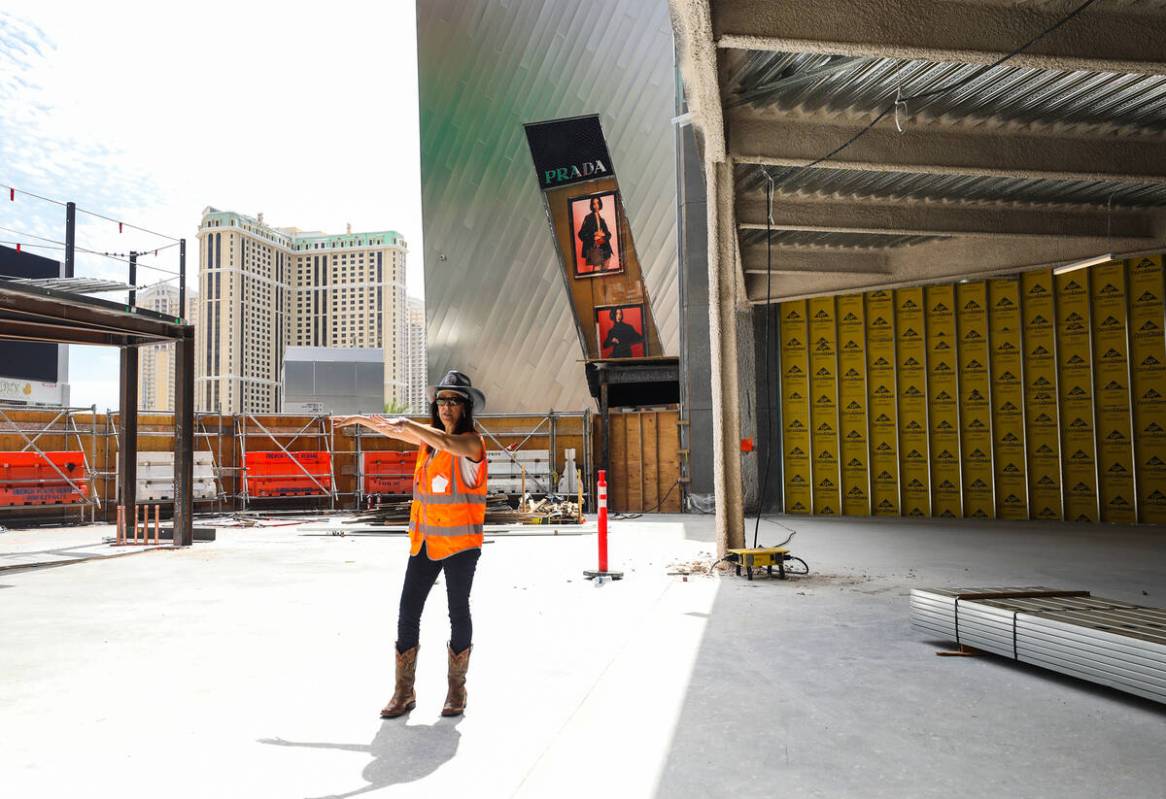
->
911, 587, 1166, 702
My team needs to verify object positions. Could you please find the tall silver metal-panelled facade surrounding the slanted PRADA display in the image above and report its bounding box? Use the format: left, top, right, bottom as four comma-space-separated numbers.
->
417, 0, 680, 412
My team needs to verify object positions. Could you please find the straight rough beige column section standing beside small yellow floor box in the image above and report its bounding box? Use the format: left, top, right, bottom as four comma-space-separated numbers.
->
705, 162, 745, 550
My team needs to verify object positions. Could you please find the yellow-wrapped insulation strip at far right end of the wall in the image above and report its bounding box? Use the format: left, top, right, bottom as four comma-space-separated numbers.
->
1126, 255, 1166, 524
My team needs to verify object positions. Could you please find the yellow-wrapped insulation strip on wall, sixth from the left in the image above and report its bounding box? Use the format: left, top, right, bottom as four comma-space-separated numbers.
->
926, 285, 963, 519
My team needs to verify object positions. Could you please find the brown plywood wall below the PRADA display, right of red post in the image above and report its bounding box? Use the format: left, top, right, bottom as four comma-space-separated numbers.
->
595, 408, 683, 513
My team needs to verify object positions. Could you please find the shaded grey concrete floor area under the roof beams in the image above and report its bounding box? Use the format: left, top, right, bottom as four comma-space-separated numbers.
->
654, 519, 1166, 799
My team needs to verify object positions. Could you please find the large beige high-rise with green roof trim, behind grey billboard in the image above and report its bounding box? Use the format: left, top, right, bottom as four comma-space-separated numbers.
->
195, 208, 408, 413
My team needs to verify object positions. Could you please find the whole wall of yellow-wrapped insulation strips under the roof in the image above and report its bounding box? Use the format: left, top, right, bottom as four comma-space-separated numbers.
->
779, 249, 1166, 524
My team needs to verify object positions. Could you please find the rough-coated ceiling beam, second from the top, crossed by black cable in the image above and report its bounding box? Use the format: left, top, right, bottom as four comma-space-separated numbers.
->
729, 112, 1166, 184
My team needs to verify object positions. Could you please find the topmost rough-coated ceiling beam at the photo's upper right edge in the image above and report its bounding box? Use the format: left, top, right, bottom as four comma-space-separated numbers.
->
711, 0, 1166, 75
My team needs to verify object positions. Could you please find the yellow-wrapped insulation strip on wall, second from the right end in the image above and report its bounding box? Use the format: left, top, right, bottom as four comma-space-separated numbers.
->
1089, 261, 1137, 524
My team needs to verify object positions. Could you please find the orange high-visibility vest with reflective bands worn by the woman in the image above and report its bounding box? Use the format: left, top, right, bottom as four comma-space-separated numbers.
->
409, 433, 486, 560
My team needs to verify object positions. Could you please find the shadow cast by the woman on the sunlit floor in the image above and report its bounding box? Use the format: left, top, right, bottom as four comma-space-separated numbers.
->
259, 716, 463, 799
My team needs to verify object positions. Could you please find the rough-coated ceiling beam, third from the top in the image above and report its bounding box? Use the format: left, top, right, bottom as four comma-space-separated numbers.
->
737, 196, 1154, 238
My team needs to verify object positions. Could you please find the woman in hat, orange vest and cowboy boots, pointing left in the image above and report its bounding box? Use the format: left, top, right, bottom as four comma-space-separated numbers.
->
337, 371, 486, 719
